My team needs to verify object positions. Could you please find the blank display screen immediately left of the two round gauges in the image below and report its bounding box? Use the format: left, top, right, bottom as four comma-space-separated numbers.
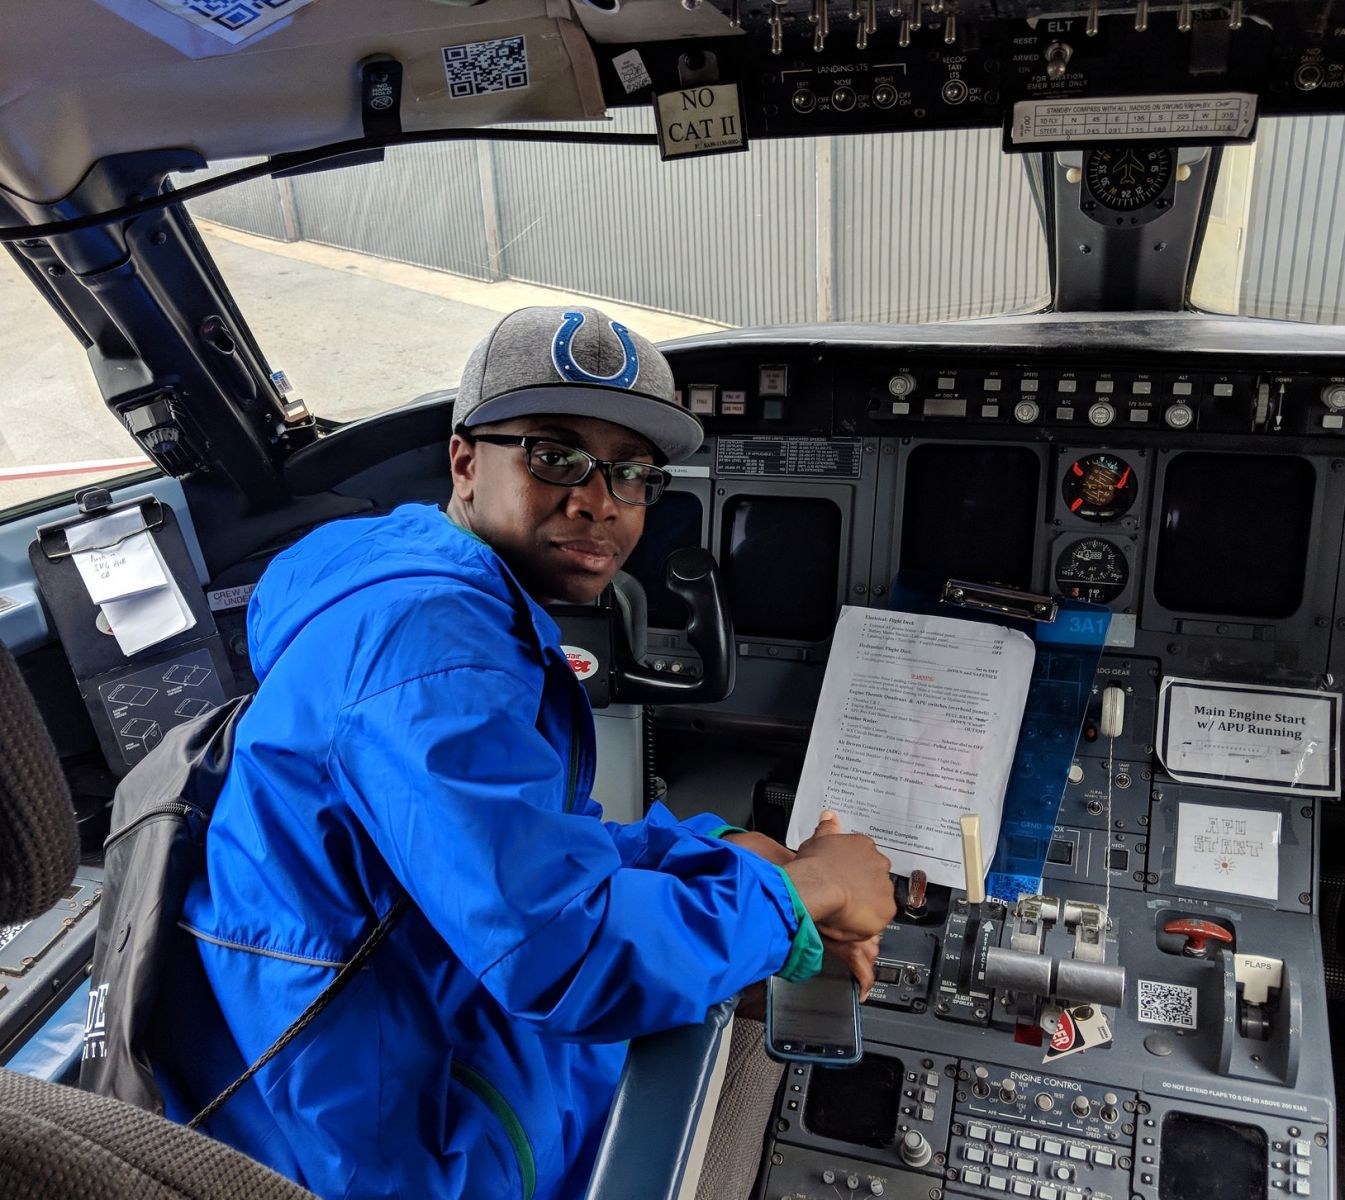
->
901, 445, 1041, 588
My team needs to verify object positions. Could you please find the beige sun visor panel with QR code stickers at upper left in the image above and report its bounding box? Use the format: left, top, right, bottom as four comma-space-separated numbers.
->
0, 0, 605, 202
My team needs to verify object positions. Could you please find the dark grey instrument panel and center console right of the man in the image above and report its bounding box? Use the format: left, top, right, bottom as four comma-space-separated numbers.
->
629, 318, 1345, 1200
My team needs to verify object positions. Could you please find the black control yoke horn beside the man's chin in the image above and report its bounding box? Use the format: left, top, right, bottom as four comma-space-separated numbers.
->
612, 546, 737, 704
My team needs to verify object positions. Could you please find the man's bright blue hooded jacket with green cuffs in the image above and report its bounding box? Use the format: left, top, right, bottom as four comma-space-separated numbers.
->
165, 504, 818, 1200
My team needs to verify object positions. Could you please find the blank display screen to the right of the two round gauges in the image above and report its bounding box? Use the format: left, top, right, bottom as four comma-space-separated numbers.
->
1154, 453, 1317, 619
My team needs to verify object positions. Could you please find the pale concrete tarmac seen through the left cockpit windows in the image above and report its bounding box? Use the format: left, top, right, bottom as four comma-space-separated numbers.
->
0, 222, 721, 514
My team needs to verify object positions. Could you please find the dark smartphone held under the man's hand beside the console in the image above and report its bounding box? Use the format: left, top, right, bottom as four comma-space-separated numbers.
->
765, 955, 863, 1067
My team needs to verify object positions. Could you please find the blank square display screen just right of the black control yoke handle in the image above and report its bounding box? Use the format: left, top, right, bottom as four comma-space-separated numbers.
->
726, 495, 841, 642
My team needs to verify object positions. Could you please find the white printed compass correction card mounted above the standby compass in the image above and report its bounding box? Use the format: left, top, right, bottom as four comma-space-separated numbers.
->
1009, 91, 1256, 145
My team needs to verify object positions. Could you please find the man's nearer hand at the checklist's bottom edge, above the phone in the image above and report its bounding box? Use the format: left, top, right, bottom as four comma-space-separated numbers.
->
783, 810, 897, 947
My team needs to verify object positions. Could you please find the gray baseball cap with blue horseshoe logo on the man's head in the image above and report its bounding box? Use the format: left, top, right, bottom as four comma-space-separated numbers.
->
453, 304, 705, 463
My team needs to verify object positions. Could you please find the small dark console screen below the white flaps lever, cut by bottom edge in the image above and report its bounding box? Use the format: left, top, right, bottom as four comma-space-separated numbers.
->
1158, 1113, 1266, 1200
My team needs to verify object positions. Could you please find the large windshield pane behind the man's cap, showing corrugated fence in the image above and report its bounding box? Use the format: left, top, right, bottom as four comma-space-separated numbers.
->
180, 110, 1049, 420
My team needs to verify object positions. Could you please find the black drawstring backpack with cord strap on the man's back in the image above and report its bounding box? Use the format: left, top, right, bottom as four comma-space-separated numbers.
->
79, 696, 406, 1127
